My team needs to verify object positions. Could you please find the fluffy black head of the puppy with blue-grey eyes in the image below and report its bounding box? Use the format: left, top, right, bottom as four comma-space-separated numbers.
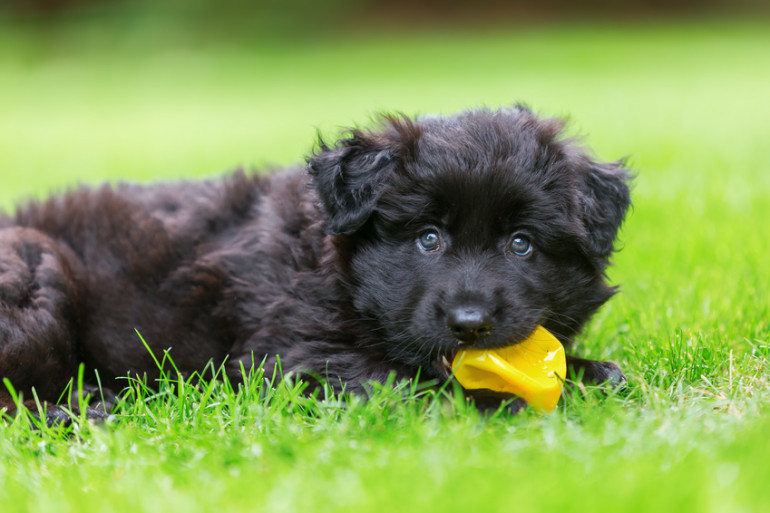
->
309, 107, 630, 375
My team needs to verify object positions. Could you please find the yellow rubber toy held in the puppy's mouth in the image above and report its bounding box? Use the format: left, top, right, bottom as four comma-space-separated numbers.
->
452, 326, 567, 412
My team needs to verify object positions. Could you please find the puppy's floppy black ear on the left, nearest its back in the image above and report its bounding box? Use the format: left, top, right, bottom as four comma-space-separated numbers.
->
308, 132, 397, 235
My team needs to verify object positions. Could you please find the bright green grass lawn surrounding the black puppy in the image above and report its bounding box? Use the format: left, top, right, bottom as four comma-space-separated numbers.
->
0, 16, 770, 513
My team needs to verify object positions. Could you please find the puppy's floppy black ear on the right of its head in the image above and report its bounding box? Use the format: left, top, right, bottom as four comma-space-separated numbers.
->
579, 159, 631, 258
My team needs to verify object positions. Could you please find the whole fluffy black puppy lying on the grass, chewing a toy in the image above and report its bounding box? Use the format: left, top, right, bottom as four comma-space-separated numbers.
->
0, 107, 630, 418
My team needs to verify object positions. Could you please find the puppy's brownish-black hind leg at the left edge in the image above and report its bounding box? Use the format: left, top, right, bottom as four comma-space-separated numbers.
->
0, 228, 99, 423
